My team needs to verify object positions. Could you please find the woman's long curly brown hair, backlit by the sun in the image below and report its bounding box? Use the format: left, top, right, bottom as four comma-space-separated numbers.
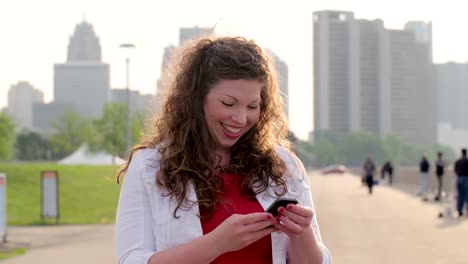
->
117, 37, 290, 217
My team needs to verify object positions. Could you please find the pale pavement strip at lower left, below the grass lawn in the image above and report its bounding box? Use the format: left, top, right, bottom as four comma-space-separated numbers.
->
1, 225, 115, 264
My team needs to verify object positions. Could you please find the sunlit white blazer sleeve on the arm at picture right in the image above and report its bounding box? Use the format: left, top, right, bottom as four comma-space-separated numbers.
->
291, 154, 333, 264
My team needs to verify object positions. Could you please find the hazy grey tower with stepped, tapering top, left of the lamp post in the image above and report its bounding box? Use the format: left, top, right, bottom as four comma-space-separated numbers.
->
54, 21, 110, 118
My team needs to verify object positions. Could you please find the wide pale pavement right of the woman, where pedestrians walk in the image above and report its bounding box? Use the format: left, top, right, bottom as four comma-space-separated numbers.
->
310, 173, 468, 264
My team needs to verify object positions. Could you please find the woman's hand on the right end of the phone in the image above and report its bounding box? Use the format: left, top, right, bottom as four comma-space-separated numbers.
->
274, 204, 314, 237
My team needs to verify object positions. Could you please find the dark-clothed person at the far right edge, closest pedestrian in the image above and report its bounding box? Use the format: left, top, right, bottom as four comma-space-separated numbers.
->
455, 148, 468, 216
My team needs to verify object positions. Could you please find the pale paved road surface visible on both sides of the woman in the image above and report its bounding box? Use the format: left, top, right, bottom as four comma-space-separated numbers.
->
2, 174, 468, 264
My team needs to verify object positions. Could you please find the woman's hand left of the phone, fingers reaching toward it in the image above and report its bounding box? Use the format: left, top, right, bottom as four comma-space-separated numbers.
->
210, 212, 277, 254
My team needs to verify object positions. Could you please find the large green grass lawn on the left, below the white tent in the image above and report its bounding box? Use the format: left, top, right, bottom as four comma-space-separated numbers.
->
0, 163, 121, 225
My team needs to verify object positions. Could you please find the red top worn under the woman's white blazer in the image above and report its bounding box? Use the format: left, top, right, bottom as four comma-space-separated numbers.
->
201, 173, 273, 264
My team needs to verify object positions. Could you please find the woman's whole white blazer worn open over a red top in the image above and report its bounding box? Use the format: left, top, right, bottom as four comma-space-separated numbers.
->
115, 148, 332, 264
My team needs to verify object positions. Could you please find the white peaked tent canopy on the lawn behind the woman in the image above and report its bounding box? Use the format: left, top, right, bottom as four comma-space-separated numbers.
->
57, 145, 125, 165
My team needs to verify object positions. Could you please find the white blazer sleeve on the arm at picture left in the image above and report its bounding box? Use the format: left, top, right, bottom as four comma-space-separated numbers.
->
115, 150, 157, 264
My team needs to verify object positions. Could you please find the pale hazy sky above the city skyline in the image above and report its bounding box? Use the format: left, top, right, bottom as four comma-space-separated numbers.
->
0, 0, 468, 138
